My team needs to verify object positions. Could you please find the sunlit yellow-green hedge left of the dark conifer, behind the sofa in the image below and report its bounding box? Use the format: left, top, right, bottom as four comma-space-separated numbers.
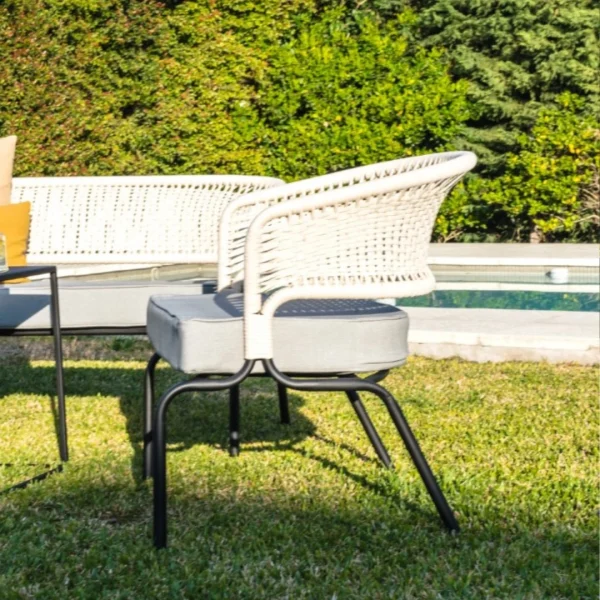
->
0, 0, 466, 180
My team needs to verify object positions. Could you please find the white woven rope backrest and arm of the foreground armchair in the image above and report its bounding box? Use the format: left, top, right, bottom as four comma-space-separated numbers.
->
233, 152, 477, 359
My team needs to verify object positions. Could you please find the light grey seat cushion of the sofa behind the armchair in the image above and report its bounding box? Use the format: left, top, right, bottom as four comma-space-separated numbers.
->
0, 279, 202, 331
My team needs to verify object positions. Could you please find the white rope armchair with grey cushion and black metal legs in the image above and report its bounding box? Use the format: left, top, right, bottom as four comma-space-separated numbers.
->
144, 152, 476, 548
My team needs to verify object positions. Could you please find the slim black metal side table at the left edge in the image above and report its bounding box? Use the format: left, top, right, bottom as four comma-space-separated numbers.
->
0, 265, 69, 493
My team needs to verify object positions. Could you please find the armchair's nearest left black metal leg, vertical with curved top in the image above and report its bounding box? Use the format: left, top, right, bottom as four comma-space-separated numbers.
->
152, 360, 255, 548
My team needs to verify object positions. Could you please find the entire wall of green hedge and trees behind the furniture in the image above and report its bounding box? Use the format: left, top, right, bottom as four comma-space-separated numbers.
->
0, 0, 600, 241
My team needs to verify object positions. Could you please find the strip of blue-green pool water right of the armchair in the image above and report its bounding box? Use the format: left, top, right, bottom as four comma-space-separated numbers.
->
396, 290, 600, 312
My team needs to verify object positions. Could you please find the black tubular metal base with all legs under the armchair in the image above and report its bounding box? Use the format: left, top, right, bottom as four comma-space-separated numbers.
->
143, 354, 459, 548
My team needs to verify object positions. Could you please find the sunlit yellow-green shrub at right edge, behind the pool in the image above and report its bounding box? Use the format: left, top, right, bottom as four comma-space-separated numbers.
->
478, 94, 600, 242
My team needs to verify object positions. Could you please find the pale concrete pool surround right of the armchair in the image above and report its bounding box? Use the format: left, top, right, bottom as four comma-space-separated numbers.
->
406, 244, 600, 365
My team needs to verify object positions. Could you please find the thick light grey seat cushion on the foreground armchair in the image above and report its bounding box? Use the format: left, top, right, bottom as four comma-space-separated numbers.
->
147, 292, 408, 374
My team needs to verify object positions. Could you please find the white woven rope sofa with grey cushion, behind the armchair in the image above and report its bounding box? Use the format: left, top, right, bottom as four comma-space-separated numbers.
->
0, 175, 283, 335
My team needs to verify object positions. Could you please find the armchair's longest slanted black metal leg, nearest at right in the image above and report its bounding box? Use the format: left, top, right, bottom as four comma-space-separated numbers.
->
374, 385, 460, 532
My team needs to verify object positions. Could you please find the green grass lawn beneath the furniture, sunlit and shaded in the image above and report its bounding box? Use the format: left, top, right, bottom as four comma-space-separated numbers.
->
0, 348, 599, 600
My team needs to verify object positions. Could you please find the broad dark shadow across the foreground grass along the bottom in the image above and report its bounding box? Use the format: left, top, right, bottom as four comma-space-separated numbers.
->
0, 477, 597, 600
